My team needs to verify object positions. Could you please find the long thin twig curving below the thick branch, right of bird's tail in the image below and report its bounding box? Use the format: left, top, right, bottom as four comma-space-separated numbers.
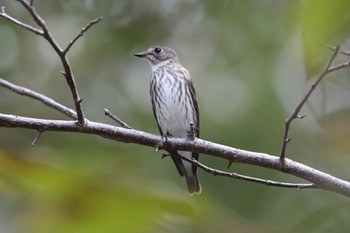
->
176, 154, 317, 190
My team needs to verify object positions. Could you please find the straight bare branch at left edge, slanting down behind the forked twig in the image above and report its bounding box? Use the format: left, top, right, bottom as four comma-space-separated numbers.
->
0, 78, 77, 120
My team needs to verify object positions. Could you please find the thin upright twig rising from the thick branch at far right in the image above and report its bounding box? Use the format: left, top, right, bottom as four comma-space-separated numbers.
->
280, 45, 344, 164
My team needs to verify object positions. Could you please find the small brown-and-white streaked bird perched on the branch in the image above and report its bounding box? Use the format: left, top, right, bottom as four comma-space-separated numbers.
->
135, 46, 202, 195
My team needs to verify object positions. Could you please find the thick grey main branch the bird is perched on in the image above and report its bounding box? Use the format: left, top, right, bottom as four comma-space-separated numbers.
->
0, 114, 350, 197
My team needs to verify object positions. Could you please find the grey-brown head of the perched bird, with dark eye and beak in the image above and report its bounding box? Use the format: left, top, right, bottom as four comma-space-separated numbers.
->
134, 46, 178, 66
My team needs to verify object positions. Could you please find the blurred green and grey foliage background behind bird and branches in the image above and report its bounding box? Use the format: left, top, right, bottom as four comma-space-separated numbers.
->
0, 0, 350, 233
